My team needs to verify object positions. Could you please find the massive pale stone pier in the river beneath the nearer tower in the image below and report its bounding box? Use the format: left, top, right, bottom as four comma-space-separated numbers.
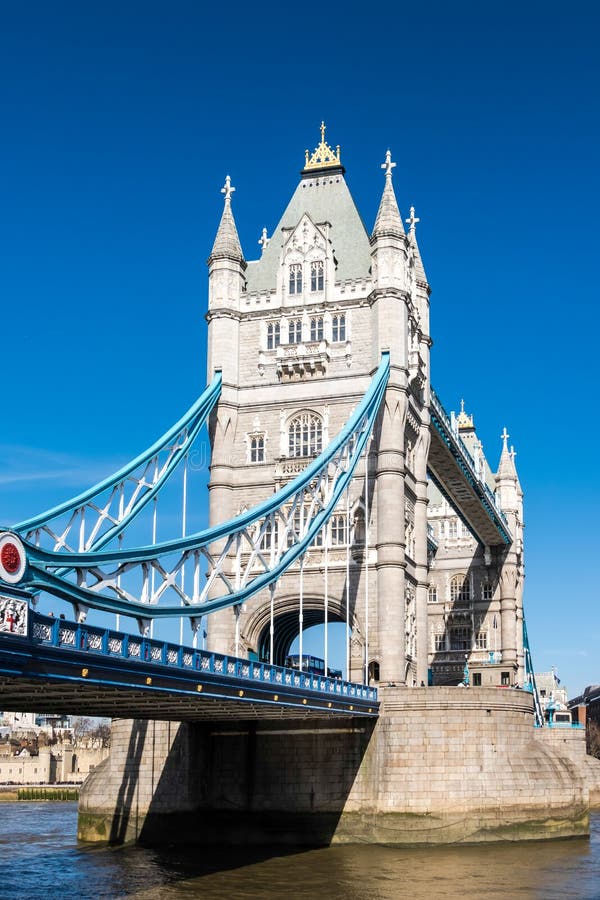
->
79, 687, 600, 846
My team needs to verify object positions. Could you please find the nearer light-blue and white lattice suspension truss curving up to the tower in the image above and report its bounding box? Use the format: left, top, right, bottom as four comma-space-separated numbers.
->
19, 356, 389, 620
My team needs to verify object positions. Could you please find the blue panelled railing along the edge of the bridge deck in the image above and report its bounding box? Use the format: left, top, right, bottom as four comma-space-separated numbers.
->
29, 610, 377, 703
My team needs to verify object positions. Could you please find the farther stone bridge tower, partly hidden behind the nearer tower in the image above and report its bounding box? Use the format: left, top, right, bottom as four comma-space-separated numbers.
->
427, 403, 524, 687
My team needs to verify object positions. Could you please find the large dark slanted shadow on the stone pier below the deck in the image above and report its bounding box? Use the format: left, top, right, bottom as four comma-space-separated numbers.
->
139, 716, 374, 855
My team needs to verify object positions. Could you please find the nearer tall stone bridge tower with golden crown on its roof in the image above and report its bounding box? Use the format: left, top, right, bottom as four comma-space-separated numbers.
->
207, 125, 430, 685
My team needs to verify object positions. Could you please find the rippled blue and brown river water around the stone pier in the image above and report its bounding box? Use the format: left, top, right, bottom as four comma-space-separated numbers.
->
0, 802, 600, 900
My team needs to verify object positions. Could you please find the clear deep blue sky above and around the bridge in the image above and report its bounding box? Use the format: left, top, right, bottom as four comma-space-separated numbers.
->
0, 0, 600, 694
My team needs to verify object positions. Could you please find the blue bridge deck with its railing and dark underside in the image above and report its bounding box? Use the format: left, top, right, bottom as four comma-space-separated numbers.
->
0, 613, 379, 721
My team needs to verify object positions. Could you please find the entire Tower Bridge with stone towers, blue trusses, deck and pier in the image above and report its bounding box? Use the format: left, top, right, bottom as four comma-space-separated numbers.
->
0, 126, 589, 843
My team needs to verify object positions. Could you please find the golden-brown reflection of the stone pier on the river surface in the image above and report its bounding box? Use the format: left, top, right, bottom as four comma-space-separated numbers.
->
130, 822, 600, 900
